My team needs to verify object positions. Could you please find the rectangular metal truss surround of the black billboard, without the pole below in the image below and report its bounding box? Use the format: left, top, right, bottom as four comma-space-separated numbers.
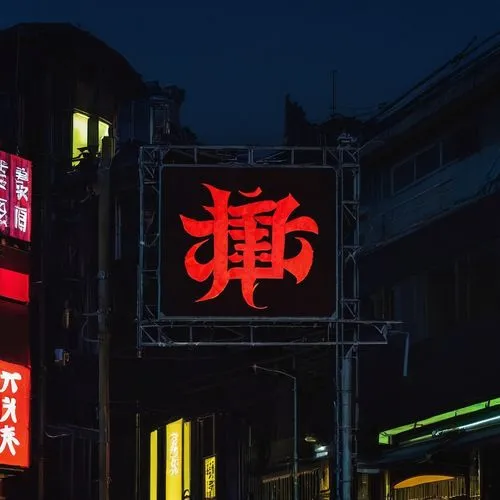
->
137, 143, 394, 350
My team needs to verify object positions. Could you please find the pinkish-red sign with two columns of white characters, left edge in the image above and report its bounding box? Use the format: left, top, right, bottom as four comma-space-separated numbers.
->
0, 151, 32, 242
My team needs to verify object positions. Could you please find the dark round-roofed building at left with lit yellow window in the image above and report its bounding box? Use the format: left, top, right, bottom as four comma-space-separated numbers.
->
0, 23, 142, 500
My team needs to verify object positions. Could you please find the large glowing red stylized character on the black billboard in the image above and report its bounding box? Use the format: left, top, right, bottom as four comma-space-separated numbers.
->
180, 184, 318, 309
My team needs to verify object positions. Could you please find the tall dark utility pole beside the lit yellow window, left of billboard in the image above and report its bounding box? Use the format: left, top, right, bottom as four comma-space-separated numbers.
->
97, 137, 114, 500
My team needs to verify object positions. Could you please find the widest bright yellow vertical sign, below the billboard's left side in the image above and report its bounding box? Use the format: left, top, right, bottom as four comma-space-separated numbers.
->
165, 419, 184, 500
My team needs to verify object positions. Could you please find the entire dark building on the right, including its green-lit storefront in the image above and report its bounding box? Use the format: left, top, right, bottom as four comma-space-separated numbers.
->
359, 36, 500, 500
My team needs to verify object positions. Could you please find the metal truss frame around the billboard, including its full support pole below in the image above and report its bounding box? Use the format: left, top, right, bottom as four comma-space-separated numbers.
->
137, 142, 400, 500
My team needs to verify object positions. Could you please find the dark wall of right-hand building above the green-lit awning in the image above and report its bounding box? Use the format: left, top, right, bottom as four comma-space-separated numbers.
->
360, 49, 500, 434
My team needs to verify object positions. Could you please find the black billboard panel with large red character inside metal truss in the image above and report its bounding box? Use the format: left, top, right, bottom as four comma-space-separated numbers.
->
162, 166, 337, 317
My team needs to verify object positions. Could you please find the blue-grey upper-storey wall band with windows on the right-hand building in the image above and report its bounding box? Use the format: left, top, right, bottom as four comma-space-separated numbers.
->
362, 100, 500, 249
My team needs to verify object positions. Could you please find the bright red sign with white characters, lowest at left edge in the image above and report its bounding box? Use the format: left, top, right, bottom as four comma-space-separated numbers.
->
0, 361, 31, 468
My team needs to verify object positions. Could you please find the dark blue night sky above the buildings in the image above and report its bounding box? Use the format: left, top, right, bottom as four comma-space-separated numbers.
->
0, 0, 500, 144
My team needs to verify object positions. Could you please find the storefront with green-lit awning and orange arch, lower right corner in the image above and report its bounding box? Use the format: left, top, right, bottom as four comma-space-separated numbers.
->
363, 398, 500, 500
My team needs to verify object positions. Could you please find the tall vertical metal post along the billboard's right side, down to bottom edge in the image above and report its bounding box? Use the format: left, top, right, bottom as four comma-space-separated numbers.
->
335, 134, 360, 500
